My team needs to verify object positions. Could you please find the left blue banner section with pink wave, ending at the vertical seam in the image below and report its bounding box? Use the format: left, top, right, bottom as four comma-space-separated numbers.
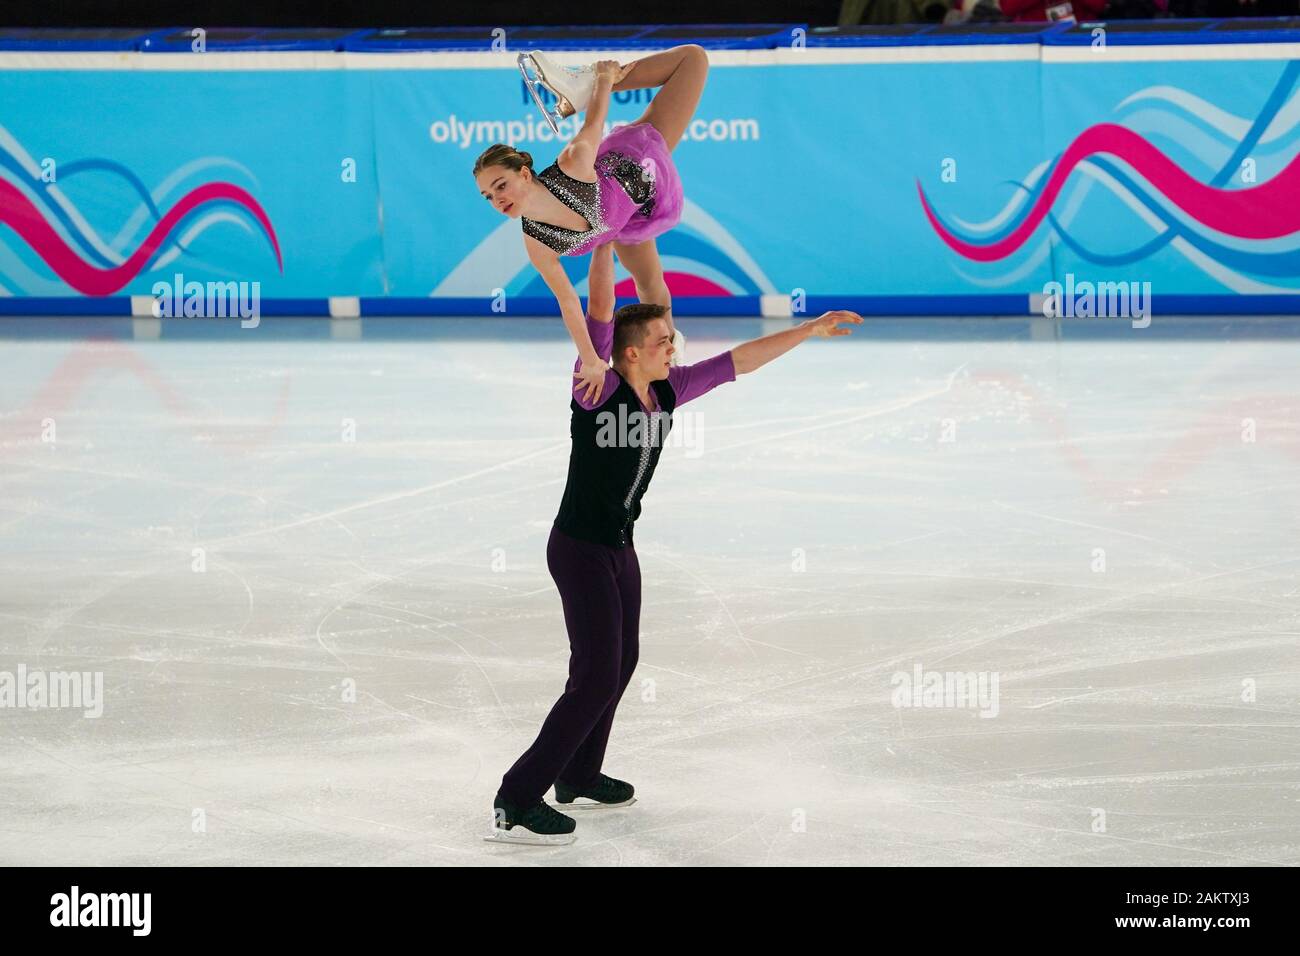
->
0, 64, 384, 298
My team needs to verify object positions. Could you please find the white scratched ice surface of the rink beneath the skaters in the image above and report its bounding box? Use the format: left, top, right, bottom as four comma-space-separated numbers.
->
0, 316, 1300, 866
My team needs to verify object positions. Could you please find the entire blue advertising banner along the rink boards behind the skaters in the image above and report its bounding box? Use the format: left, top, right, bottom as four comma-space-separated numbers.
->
0, 43, 1300, 313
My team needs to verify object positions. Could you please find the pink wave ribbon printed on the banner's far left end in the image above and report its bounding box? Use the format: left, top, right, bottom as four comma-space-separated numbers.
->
0, 179, 285, 295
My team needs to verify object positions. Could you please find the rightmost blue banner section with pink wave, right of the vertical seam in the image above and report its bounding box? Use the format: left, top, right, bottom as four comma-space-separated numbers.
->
1029, 55, 1300, 295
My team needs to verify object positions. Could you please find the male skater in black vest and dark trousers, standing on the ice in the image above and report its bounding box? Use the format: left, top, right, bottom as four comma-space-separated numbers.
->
486, 243, 862, 844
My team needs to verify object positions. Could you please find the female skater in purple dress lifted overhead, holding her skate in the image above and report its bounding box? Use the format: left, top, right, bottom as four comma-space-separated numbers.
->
475, 43, 709, 401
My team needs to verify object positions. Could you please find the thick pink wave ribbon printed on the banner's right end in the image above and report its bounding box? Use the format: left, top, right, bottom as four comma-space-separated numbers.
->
917, 122, 1300, 263
